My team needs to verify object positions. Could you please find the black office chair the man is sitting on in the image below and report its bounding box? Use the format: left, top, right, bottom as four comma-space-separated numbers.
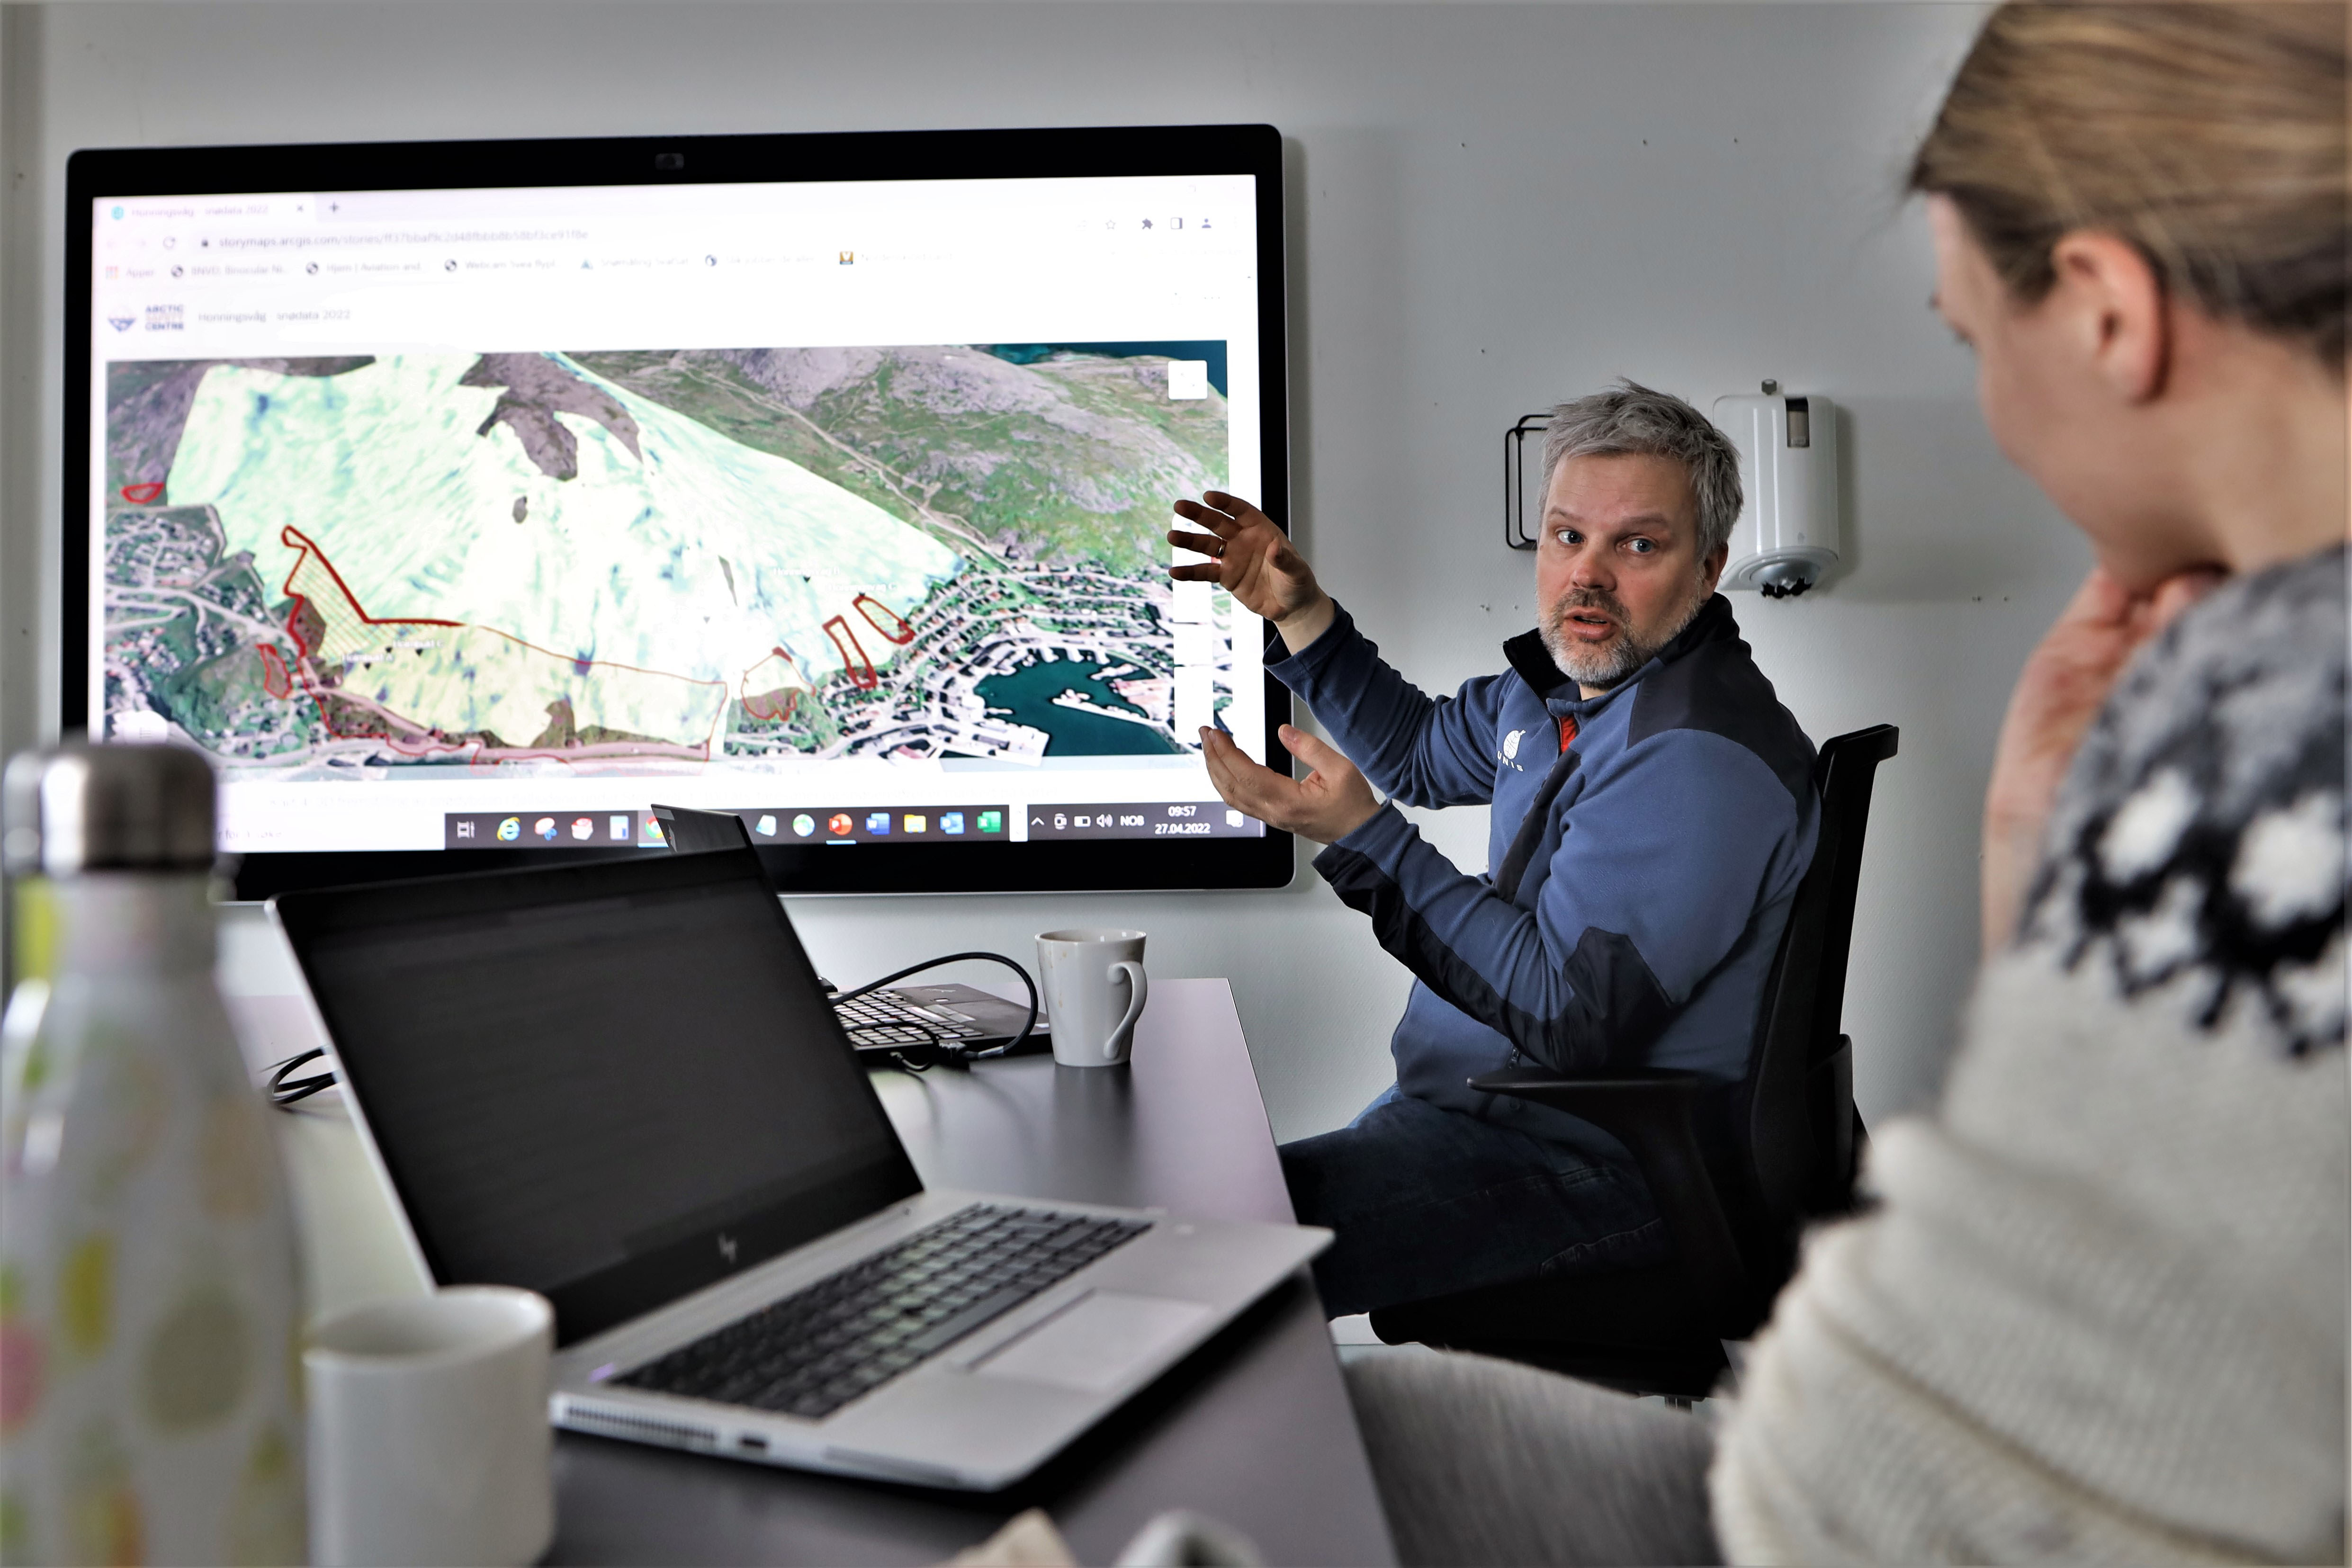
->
1371, 724, 1901, 1399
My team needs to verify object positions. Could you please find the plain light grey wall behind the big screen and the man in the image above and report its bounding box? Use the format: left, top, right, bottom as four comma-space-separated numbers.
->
0, 0, 2086, 1136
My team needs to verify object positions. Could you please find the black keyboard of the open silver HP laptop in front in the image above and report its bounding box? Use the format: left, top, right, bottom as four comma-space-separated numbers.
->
619, 1204, 1150, 1420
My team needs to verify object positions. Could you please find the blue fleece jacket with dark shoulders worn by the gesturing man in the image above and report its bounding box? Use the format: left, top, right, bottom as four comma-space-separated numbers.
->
1270, 595, 1818, 1154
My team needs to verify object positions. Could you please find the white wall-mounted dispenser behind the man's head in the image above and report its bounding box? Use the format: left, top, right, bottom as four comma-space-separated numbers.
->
1715, 381, 1841, 600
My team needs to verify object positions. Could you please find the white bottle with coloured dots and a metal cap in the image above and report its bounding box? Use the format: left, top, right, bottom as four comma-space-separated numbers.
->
0, 745, 306, 1563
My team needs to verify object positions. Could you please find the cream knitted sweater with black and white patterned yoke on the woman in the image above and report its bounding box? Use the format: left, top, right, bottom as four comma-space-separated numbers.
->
1712, 548, 2352, 1563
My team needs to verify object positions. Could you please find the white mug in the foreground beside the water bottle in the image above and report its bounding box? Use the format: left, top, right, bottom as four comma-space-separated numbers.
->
304, 1286, 555, 1568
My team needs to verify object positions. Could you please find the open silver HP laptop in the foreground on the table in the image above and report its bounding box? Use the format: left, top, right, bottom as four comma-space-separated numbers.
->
270, 851, 1331, 1490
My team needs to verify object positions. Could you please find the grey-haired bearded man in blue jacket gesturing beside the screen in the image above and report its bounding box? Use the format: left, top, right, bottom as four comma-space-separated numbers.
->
1169, 381, 1818, 1317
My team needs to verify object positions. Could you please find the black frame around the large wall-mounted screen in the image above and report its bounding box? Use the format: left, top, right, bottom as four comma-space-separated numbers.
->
59, 125, 1296, 898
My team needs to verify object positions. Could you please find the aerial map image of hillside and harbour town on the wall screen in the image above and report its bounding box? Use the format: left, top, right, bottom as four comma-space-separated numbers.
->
104, 343, 1235, 778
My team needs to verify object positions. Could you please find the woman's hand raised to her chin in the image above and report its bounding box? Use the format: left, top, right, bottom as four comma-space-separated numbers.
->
1983, 566, 2220, 959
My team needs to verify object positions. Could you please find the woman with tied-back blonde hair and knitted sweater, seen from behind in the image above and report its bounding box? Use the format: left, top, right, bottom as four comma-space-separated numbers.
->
1350, 2, 2352, 1563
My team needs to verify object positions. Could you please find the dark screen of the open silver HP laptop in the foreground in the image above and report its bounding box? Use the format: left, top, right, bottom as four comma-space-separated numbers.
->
278, 851, 922, 1344
